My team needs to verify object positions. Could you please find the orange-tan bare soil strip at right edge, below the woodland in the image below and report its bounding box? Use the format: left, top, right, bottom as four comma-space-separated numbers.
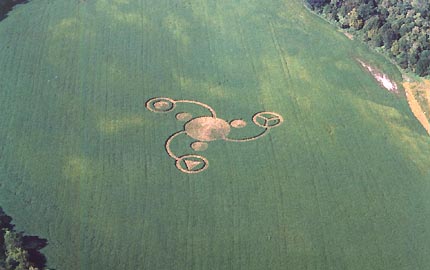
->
403, 80, 430, 135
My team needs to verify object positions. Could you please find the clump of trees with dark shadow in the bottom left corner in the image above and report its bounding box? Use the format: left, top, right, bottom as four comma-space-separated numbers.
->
0, 207, 48, 269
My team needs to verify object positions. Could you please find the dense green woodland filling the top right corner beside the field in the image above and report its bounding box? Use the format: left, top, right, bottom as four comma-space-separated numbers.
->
306, 0, 430, 76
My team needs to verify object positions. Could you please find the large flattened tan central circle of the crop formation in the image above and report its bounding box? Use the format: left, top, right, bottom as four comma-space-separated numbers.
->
185, 117, 230, 142
